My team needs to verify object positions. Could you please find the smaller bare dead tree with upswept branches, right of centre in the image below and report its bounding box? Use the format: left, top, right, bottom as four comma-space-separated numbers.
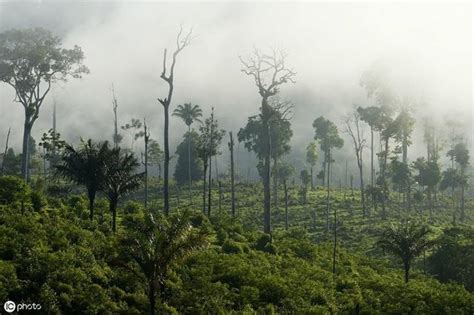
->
345, 108, 367, 217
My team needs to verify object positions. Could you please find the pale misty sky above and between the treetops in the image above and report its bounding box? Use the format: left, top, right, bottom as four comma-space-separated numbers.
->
0, 1, 473, 175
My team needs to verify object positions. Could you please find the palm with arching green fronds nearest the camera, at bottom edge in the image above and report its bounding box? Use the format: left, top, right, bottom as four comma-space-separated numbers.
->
120, 213, 207, 315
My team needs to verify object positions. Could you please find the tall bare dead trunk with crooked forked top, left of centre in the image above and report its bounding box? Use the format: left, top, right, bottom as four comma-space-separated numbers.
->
158, 27, 192, 215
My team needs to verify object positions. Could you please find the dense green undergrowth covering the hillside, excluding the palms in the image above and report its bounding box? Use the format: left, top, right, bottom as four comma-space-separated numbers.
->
0, 178, 474, 314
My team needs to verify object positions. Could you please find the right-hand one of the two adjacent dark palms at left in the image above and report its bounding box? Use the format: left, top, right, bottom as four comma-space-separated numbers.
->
104, 147, 144, 232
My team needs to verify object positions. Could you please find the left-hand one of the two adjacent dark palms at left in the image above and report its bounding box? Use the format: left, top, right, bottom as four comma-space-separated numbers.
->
55, 139, 109, 220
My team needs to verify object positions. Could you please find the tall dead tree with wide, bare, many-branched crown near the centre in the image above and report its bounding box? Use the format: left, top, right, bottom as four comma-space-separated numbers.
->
240, 49, 296, 233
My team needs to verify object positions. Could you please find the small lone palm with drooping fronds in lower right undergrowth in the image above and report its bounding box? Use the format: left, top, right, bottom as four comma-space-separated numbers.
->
378, 220, 433, 283
